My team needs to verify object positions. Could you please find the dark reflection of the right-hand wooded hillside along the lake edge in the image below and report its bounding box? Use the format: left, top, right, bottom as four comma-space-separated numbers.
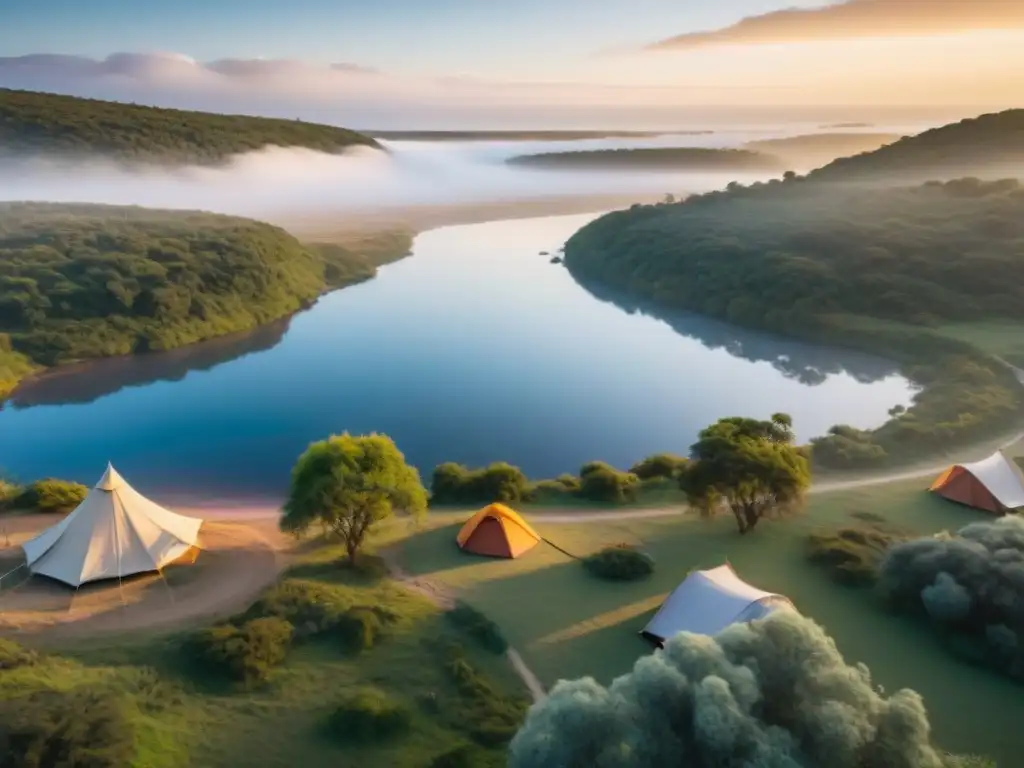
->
569, 272, 899, 386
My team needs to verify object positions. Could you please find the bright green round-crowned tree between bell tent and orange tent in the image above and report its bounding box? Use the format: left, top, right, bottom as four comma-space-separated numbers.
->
281, 432, 427, 564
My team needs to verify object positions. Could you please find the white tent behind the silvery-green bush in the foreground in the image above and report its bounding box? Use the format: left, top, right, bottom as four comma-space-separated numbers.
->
640, 564, 796, 645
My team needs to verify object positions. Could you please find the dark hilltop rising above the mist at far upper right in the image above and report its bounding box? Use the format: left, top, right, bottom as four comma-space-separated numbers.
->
811, 110, 1024, 182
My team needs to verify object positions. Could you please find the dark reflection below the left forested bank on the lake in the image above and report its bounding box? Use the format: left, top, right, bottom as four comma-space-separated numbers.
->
7, 317, 292, 410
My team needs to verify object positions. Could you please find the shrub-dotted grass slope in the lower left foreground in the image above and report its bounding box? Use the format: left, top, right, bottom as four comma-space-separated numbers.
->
0, 547, 525, 768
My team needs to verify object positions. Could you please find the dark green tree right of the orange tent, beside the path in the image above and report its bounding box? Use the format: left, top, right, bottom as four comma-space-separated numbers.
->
680, 414, 811, 534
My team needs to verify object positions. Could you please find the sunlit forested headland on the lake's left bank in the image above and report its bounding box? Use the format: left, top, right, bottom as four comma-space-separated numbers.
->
0, 203, 411, 392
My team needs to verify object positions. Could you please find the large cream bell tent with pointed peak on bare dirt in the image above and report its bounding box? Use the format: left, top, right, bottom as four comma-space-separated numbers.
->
22, 465, 203, 587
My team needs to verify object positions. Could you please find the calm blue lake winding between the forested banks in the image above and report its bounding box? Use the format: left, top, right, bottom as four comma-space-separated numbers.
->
0, 215, 913, 501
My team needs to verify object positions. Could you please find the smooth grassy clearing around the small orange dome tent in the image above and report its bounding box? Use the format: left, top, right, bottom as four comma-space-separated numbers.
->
382, 479, 1024, 765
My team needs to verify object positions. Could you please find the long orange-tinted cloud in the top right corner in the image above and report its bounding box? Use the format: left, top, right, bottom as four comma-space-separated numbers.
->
647, 0, 1024, 50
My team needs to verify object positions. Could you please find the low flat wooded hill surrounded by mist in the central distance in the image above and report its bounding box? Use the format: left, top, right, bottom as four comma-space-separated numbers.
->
507, 146, 785, 171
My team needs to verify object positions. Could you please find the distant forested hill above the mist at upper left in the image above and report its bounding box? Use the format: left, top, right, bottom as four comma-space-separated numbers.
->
0, 89, 380, 164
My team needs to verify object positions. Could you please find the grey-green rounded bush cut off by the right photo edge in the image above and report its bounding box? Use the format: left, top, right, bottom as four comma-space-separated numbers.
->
879, 515, 1024, 682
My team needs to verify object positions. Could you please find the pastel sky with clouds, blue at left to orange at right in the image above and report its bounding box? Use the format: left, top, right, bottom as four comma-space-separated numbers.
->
0, 0, 1024, 124
